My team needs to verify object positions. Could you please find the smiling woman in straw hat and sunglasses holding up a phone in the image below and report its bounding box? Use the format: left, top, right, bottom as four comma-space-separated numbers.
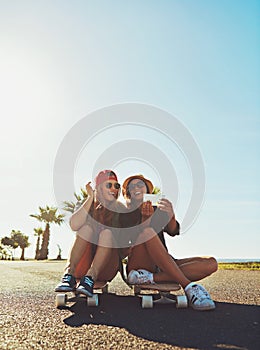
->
120, 175, 217, 310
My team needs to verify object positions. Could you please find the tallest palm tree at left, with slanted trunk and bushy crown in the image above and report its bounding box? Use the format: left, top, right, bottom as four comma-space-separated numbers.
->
30, 205, 65, 260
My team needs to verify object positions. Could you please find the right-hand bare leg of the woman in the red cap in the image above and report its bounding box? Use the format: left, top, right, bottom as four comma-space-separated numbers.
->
86, 229, 119, 281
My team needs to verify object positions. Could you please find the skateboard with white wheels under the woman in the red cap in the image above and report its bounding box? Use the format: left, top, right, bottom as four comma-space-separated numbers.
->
55, 281, 108, 307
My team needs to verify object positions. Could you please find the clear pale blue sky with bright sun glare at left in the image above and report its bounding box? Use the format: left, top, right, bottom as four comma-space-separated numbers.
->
0, 0, 260, 259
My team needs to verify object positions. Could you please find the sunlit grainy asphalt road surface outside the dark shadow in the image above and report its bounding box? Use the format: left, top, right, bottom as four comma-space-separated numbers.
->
0, 261, 260, 350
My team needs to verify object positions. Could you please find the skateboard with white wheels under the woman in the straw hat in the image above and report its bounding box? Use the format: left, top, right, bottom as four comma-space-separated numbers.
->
133, 283, 188, 309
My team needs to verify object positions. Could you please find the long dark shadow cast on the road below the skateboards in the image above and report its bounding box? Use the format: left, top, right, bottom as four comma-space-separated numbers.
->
64, 294, 260, 350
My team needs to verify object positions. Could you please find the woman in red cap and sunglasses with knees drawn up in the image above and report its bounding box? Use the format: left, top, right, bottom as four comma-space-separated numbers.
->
55, 170, 125, 296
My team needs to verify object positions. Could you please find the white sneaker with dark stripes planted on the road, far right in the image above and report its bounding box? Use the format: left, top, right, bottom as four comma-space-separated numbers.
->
185, 283, 215, 311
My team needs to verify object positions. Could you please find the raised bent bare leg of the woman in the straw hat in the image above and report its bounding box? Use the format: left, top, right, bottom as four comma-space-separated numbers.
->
128, 228, 191, 288
